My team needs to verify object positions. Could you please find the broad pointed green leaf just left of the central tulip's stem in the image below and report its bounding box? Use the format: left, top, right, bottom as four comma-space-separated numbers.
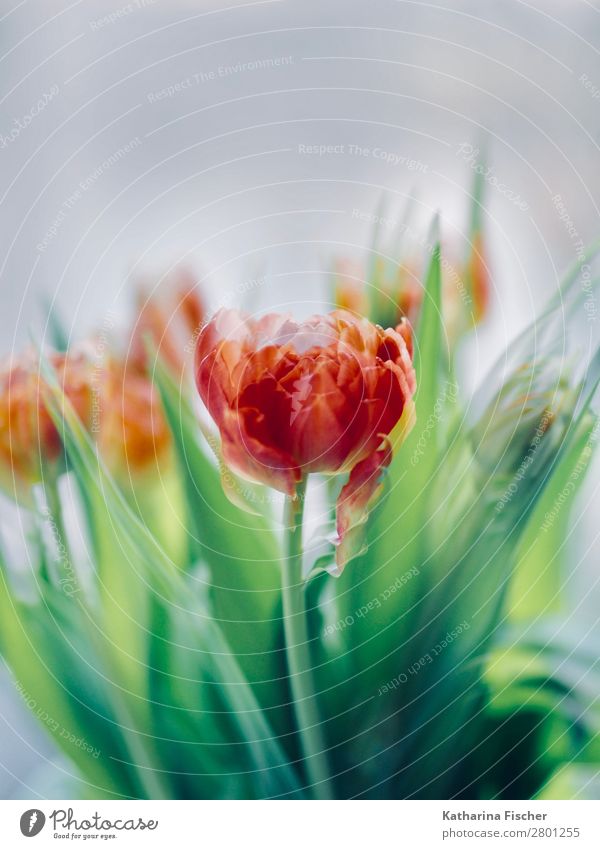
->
149, 360, 290, 733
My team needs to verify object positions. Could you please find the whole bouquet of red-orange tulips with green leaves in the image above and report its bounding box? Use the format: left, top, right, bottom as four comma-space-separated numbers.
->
0, 174, 600, 799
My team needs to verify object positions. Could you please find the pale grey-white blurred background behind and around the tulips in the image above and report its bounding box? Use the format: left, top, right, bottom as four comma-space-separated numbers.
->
0, 0, 600, 798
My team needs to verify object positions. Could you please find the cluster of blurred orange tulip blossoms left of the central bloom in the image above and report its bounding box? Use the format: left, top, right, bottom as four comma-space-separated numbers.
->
0, 273, 204, 505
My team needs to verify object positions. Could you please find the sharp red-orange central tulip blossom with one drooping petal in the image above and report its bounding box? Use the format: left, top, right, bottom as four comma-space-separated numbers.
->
195, 310, 415, 569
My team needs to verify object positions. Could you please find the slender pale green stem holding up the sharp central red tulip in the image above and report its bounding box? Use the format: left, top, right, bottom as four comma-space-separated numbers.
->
282, 481, 333, 799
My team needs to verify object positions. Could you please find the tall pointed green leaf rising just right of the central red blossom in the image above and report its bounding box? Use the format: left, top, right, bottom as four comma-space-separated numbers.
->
317, 220, 456, 792
